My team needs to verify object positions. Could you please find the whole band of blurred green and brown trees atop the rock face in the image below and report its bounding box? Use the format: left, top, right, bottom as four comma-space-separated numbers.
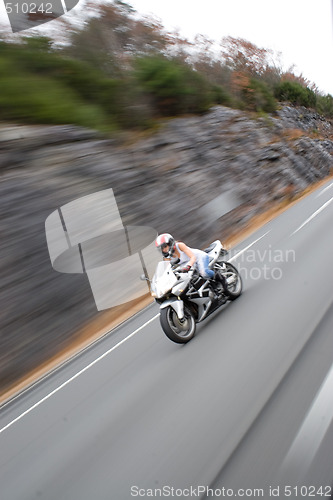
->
0, 1, 333, 132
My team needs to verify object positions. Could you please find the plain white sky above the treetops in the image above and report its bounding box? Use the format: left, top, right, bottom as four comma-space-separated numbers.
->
0, 0, 333, 95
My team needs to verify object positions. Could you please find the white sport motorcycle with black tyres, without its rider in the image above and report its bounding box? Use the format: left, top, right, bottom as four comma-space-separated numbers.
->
147, 240, 243, 344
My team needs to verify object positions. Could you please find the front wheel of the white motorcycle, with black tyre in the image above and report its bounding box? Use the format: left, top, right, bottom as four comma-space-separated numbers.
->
160, 306, 195, 344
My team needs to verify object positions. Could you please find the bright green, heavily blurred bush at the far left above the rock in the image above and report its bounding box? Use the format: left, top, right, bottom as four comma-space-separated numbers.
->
0, 39, 120, 131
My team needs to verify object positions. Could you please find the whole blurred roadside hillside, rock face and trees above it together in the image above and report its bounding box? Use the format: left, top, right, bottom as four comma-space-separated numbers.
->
0, 1, 333, 393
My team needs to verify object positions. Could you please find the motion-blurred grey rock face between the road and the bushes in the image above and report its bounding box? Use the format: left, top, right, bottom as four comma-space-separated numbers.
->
0, 107, 333, 388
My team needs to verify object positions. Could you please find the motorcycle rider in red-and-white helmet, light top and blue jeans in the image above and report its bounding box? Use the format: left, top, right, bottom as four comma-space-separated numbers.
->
155, 233, 227, 291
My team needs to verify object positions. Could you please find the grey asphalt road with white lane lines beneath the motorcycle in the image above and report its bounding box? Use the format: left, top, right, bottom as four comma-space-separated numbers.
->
0, 182, 333, 500
